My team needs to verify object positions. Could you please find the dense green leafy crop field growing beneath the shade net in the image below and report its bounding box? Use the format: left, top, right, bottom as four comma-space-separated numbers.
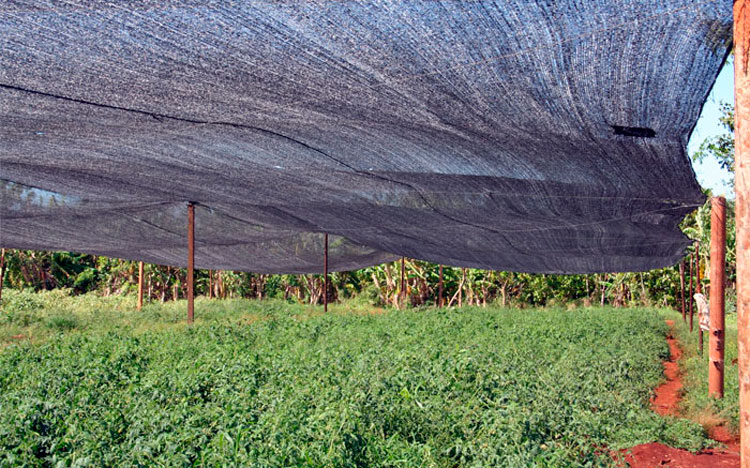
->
0, 291, 709, 468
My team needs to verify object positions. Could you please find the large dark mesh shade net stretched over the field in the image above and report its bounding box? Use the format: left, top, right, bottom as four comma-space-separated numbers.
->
0, 0, 732, 273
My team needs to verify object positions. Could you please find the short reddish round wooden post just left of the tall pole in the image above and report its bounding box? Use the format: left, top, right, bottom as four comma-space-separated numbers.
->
708, 197, 727, 398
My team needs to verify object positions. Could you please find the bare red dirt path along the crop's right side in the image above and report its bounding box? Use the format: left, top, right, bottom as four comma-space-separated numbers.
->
623, 320, 740, 468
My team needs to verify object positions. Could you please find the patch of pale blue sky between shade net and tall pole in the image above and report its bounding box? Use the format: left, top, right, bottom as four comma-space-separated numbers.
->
688, 59, 734, 198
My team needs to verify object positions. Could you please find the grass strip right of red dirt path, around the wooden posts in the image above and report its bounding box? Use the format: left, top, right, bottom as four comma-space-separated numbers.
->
665, 311, 740, 434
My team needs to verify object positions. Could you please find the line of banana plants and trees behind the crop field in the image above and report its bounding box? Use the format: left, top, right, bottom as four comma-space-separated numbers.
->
4, 194, 736, 311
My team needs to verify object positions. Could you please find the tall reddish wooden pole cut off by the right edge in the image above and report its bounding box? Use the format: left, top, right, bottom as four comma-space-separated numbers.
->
734, 0, 750, 462
